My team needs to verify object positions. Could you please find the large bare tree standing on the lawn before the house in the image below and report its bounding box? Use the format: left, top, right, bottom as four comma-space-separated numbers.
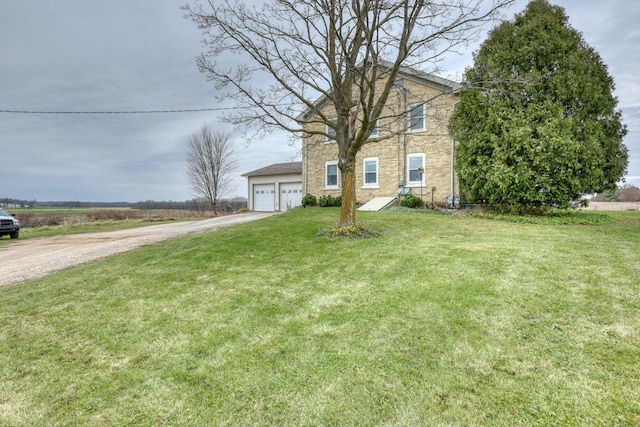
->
183, 0, 513, 226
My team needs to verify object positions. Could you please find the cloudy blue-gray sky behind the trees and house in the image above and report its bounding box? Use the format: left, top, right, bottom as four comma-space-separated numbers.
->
0, 0, 640, 202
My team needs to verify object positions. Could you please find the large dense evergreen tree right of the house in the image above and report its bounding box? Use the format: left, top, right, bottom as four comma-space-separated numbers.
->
450, 0, 628, 210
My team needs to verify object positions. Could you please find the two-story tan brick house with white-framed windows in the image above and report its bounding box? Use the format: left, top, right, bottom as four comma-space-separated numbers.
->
302, 64, 461, 205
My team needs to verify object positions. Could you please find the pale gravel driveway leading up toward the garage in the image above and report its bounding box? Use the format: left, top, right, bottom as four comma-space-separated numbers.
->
0, 212, 274, 287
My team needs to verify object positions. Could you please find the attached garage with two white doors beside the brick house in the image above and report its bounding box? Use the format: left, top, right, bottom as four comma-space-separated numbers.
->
242, 162, 303, 212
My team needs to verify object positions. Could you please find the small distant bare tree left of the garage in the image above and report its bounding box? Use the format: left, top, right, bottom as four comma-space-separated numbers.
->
187, 125, 237, 215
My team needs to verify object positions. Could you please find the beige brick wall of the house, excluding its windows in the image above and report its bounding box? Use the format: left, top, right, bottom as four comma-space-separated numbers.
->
302, 76, 459, 204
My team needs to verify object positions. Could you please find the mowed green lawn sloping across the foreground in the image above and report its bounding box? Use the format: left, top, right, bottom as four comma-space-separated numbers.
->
0, 208, 640, 426
